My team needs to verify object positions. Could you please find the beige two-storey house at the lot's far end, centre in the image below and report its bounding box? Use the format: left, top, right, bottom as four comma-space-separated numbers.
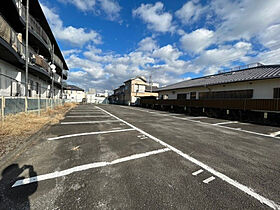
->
110, 76, 159, 105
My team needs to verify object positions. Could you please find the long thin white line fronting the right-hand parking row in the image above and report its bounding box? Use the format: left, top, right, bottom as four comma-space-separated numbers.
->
123, 107, 280, 139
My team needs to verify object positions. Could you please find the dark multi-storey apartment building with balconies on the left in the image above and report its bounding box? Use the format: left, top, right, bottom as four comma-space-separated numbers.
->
0, 0, 68, 98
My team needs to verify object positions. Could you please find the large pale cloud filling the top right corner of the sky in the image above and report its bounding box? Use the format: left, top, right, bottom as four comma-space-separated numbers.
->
211, 0, 280, 42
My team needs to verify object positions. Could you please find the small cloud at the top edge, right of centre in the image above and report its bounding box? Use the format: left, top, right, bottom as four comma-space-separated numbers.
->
175, 1, 206, 24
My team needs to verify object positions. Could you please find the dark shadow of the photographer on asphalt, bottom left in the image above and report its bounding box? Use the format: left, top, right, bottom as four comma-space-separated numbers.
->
0, 164, 38, 210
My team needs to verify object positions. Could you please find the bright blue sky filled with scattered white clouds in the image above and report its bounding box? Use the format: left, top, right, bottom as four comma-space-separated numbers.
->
40, 0, 280, 91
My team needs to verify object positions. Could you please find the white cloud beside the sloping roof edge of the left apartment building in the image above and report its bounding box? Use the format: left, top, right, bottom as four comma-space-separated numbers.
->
41, 4, 101, 47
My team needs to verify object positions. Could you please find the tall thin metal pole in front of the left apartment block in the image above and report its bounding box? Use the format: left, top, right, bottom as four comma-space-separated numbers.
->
25, 0, 29, 97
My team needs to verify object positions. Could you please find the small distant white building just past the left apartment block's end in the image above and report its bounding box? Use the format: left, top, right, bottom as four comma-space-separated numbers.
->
64, 85, 86, 103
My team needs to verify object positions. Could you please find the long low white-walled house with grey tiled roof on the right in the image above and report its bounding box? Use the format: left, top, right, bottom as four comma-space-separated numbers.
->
155, 63, 280, 100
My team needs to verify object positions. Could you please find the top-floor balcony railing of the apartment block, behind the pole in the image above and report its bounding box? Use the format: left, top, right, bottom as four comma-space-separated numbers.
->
13, 0, 52, 52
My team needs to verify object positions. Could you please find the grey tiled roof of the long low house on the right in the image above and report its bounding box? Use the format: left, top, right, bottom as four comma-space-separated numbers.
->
157, 65, 280, 92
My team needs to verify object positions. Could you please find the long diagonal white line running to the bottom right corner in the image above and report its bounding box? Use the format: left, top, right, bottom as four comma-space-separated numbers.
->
96, 107, 280, 209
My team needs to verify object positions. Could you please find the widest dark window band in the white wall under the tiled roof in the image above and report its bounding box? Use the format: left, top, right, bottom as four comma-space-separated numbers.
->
199, 89, 253, 99
